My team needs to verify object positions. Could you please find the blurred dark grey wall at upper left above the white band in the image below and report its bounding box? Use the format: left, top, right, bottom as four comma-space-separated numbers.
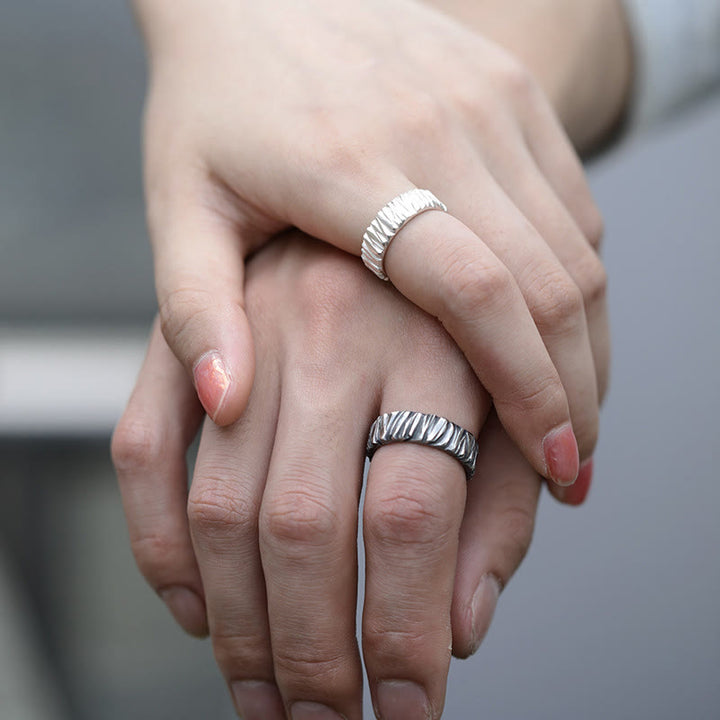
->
0, 0, 154, 324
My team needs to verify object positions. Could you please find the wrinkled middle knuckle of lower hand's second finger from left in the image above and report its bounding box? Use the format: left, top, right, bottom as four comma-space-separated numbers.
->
188, 484, 258, 539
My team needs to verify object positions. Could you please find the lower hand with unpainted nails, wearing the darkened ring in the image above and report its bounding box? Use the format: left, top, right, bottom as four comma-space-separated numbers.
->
113, 237, 589, 720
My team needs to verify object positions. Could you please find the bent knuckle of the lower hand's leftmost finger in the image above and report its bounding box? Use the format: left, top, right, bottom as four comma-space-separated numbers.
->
110, 410, 167, 476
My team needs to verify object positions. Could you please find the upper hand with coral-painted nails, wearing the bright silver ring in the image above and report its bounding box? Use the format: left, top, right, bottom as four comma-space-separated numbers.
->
136, 0, 608, 485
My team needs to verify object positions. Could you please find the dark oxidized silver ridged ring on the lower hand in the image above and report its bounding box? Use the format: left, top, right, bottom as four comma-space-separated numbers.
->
366, 410, 478, 480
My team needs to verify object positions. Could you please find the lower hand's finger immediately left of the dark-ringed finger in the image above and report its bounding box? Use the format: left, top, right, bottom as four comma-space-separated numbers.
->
260, 376, 369, 720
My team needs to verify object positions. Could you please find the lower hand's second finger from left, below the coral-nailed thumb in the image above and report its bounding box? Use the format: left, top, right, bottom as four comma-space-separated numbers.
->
188, 366, 285, 720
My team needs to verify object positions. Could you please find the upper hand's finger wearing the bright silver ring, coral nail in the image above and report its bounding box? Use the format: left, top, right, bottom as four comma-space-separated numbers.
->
387, 205, 578, 485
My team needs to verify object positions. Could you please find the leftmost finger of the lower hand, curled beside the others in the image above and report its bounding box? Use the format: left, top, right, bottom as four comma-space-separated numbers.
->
112, 322, 207, 636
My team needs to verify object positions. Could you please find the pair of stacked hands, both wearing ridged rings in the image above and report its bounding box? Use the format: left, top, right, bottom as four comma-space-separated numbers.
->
113, 0, 632, 720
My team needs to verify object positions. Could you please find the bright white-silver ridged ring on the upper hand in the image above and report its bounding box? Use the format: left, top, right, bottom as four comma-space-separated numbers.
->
360, 188, 447, 280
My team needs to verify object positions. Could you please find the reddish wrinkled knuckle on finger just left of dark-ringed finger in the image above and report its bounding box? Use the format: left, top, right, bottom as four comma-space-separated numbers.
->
260, 486, 340, 553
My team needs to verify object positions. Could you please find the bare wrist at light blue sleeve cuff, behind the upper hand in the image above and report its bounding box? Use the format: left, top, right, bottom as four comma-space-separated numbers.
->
427, 0, 633, 151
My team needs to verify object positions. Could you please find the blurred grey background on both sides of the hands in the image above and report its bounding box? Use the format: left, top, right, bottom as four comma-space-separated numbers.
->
0, 0, 720, 720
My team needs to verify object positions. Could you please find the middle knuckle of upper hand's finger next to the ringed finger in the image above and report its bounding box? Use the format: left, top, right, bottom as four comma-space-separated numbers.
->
529, 271, 585, 334
